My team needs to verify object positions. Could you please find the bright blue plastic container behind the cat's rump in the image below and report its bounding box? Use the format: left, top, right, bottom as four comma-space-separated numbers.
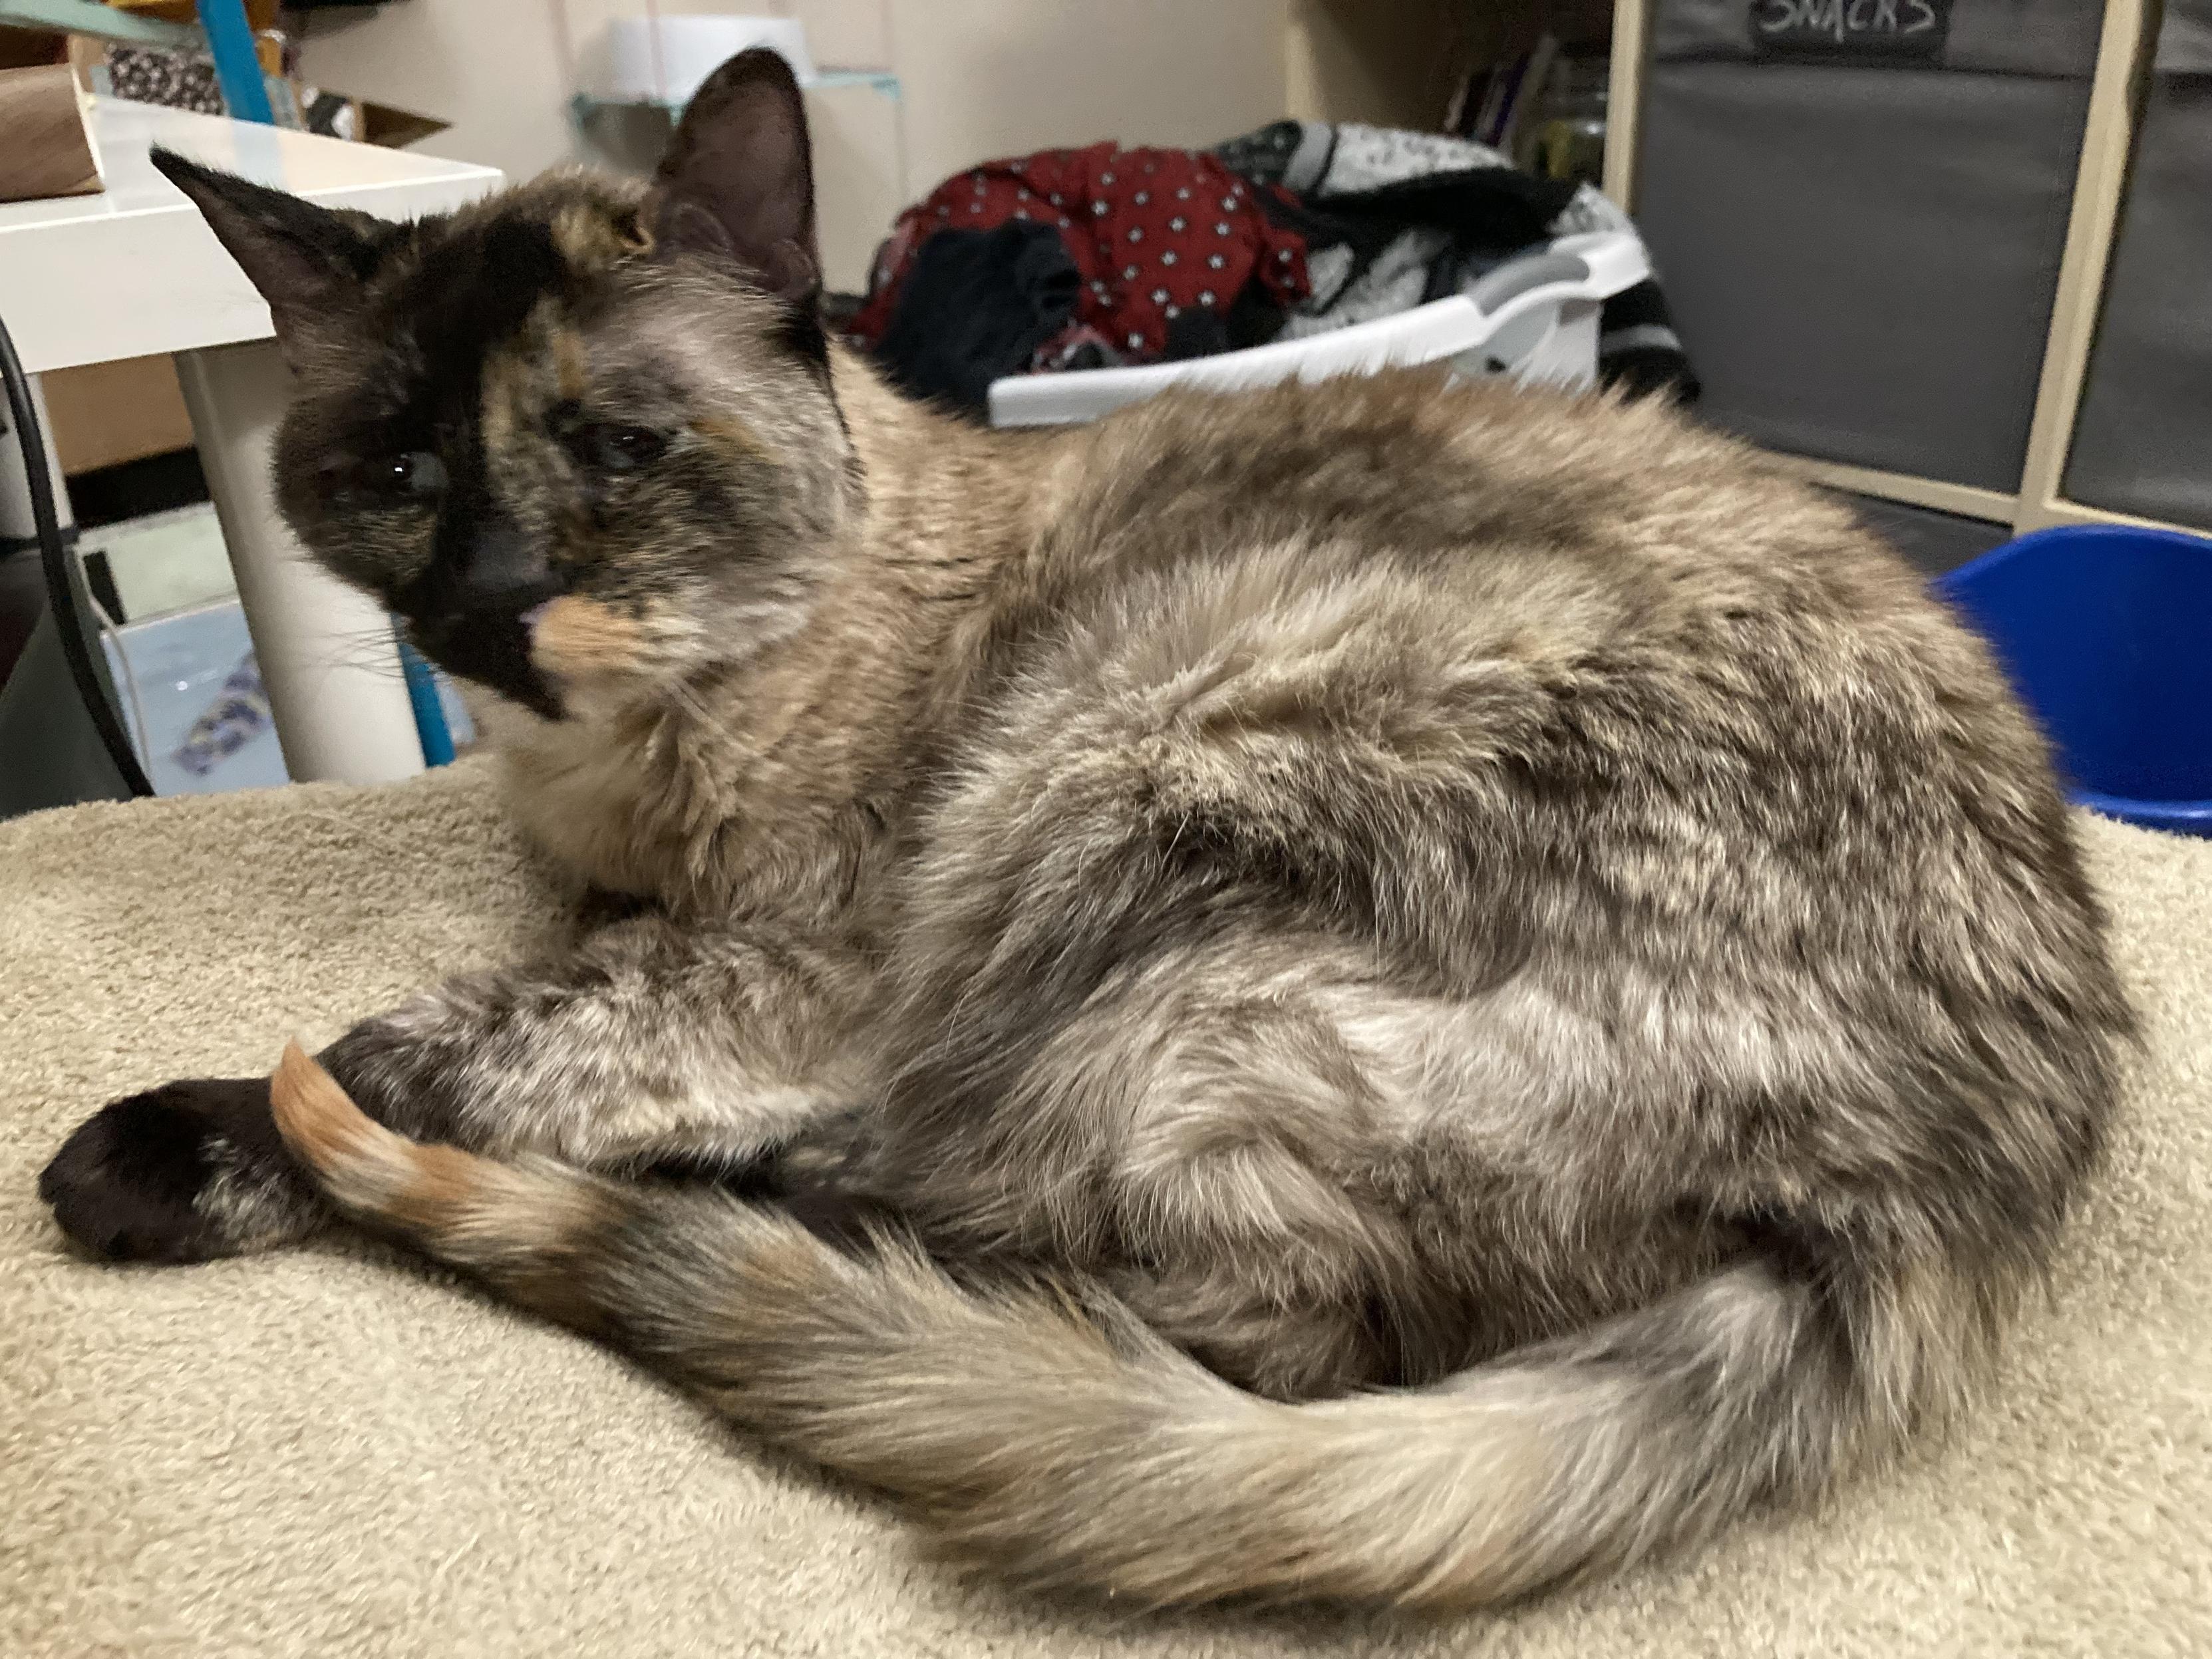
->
1935, 524, 2212, 836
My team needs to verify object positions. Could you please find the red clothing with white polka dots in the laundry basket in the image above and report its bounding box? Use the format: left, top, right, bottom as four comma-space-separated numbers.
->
850, 144, 1307, 367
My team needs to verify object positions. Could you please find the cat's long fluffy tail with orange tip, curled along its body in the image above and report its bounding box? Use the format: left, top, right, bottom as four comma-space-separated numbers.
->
272, 1046, 1984, 1608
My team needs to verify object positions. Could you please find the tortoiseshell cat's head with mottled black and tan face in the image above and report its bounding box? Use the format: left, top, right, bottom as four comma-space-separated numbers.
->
166, 60, 852, 716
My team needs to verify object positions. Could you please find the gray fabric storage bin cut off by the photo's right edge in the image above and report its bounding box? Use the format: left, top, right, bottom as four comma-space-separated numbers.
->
2066, 0, 2212, 529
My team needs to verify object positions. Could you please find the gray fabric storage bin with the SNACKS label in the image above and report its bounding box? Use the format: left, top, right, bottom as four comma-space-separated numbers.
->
1637, 0, 2102, 491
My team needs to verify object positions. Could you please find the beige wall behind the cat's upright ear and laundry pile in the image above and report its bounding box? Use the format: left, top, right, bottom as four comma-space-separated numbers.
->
303, 0, 1292, 287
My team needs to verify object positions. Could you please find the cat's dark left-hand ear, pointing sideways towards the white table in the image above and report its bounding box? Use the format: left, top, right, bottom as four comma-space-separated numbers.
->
152, 148, 389, 367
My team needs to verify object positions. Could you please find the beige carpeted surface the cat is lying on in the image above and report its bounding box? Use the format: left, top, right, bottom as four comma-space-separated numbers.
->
0, 763, 2212, 1659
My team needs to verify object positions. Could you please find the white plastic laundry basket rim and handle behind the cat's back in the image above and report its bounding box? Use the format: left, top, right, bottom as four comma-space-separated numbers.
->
991, 230, 1650, 427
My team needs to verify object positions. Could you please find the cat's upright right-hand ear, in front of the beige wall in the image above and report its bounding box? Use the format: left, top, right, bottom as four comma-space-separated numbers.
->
651, 47, 823, 305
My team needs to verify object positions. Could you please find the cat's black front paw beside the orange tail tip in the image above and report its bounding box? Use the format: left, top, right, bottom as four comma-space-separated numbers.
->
38, 1077, 319, 1261
